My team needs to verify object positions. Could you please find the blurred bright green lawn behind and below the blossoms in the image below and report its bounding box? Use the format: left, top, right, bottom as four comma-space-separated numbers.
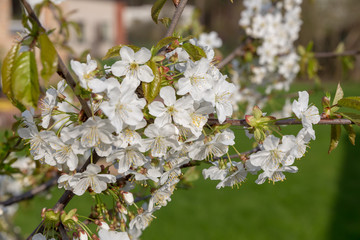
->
12, 84, 360, 240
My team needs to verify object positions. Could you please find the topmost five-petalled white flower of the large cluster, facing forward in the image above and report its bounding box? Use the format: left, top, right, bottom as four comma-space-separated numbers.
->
111, 46, 154, 89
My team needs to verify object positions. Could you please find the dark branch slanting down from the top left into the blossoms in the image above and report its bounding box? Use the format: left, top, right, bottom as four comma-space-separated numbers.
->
20, 0, 92, 118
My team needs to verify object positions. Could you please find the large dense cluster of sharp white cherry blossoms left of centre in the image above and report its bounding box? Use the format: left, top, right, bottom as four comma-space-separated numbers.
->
18, 39, 236, 239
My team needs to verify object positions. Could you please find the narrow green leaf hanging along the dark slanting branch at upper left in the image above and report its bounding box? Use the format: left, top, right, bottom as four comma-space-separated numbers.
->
38, 33, 58, 82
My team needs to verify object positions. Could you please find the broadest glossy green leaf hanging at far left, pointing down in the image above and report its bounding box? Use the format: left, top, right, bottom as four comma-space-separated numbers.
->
11, 51, 40, 107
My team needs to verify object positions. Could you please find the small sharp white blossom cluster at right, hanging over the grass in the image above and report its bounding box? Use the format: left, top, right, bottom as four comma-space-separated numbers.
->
203, 91, 320, 188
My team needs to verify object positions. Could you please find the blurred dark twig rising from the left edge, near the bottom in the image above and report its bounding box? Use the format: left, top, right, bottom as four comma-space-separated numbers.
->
0, 176, 58, 207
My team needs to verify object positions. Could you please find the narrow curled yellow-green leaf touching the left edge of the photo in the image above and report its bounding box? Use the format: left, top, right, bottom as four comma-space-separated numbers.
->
1, 43, 20, 98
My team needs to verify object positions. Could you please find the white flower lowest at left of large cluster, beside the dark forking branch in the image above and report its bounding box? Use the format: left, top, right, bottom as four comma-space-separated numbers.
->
69, 164, 116, 196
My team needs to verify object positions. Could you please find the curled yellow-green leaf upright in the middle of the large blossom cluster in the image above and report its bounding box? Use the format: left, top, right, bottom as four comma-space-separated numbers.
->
142, 61, 161, 104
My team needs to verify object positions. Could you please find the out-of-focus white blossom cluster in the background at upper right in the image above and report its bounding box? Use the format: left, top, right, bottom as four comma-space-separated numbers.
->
233, 0, 302, 114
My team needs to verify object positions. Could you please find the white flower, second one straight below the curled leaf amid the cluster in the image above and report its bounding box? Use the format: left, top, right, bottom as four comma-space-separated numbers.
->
142, 124, 179, 157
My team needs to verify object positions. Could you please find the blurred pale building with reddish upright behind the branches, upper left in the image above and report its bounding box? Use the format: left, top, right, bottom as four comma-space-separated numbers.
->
0, 0, 194, 59
